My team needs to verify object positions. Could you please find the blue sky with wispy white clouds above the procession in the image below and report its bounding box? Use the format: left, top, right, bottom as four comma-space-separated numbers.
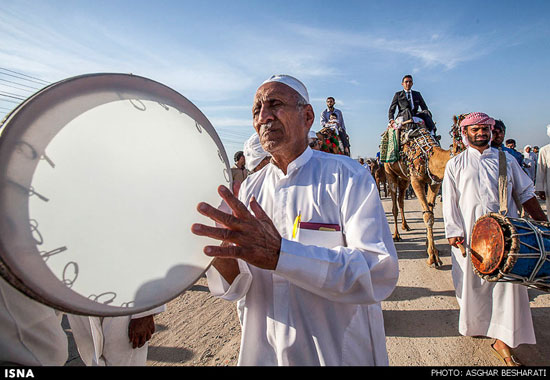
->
0, 0, 550, 159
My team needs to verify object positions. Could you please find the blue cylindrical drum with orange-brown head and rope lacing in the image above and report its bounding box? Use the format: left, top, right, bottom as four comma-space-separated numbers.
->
470, 213, 550, 292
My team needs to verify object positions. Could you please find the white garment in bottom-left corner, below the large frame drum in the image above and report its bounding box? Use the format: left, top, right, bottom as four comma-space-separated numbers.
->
0, 277, 69, 366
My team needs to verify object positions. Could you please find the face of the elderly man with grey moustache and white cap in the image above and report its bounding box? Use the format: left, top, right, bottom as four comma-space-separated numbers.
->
252, 82, 314, 155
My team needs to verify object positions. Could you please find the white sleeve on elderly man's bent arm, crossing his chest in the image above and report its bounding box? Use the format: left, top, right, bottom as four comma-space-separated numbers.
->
275, 170, 399, 304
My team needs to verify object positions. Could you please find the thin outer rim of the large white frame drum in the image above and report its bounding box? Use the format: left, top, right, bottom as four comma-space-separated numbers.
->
0, 73, 232, 316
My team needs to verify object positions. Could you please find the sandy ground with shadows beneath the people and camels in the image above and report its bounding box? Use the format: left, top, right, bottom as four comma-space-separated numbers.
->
64, 194, 550, 366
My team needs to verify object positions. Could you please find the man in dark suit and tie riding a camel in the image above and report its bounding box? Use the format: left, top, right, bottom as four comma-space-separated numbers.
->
388, 75, 435, 133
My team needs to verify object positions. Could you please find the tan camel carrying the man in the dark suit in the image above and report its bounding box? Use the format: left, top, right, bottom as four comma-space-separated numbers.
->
384, 115, 465, 268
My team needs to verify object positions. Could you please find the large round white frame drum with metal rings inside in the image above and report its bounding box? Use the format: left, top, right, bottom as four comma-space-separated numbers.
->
0, 74, 231, 316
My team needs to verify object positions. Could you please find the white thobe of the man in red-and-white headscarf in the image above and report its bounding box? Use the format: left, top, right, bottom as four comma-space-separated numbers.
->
443, 147, 535, 348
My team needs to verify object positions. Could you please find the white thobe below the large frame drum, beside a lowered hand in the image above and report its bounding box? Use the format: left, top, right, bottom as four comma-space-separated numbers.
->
67, 305, 166, 366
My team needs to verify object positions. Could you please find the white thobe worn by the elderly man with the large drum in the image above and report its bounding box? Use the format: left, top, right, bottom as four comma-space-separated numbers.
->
207, 147, 398, 366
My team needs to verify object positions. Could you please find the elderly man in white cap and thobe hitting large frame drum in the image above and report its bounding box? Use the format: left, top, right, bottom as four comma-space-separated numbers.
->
192, 75, 398, 365
